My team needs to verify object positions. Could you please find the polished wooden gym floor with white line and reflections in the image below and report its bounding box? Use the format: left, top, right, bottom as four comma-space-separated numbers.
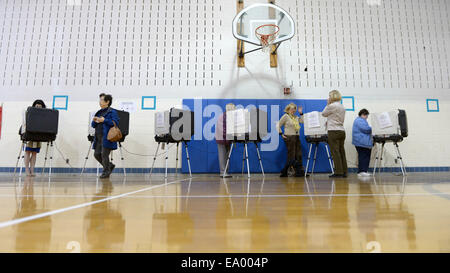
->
0, 173, 450, 252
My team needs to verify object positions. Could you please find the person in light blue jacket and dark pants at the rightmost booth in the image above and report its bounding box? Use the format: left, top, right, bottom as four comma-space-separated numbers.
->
352, 109, 373, 176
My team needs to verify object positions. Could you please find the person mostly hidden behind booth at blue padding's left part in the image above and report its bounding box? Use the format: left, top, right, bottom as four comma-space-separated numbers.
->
215, 103, 236, 178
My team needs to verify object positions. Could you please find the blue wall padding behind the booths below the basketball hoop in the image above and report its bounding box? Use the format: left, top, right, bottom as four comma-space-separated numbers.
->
182, 99, 331, 173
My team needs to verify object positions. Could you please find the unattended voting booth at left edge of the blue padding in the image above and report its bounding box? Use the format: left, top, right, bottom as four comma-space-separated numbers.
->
150, 107, 194, 178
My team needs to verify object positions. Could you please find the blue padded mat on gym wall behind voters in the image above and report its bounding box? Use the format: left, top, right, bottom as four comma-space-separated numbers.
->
182, 99, 330, 173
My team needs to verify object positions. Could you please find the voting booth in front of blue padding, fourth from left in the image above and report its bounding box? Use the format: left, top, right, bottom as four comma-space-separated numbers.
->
225, 108, 268, 178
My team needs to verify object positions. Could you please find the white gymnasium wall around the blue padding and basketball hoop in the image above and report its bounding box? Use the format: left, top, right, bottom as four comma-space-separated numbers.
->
0, 0, 450, 172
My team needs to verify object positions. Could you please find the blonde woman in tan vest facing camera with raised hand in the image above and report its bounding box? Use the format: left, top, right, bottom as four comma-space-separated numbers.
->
277, 103, 308, 177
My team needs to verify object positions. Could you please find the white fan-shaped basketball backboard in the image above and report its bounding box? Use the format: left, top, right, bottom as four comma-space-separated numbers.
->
233, 4, 295, 46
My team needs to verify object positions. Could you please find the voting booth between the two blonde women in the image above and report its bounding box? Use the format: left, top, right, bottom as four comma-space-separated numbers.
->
303, 111, 334, 176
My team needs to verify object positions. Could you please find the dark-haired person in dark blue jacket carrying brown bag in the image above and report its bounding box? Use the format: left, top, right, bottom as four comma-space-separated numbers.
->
91, 93, 119, 178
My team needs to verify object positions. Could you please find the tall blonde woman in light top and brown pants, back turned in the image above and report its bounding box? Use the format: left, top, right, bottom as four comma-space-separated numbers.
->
322, 90, 348, 178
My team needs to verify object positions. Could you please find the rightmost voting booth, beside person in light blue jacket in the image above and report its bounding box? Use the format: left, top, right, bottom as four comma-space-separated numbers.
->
371, 109, 408, 176
